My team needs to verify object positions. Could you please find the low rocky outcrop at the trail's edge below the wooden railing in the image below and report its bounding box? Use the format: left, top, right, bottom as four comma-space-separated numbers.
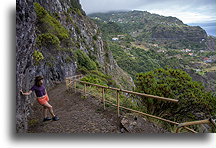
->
120, 114, 166, 133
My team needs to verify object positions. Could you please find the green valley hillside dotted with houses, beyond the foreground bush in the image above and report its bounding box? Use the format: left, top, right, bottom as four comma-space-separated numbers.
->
90, 11, 216, 92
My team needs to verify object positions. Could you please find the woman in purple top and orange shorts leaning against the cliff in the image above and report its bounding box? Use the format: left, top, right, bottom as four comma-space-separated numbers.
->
20, 76, 59, 122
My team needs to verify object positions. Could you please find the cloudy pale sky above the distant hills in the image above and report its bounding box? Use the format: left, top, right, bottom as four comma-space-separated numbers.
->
80, 0, 216, 23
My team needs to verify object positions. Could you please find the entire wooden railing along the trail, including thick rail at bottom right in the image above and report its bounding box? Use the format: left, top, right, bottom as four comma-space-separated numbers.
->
66, 75, 216, 133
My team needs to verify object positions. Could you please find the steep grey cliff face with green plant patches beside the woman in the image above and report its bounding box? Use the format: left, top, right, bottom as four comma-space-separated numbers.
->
16, 0, 133, 132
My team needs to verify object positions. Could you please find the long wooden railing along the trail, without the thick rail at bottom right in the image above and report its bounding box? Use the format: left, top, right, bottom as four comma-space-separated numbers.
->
66, 75, 204, 133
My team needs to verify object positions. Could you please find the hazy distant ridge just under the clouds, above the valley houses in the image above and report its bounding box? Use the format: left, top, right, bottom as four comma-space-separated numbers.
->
89, 11, 207, 50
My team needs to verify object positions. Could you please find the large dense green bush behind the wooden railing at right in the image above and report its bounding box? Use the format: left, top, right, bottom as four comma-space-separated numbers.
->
135, 68, 216, 122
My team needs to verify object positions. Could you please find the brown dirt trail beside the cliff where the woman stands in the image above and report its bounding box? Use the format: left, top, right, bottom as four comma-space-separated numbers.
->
28, 83, 165, 133
